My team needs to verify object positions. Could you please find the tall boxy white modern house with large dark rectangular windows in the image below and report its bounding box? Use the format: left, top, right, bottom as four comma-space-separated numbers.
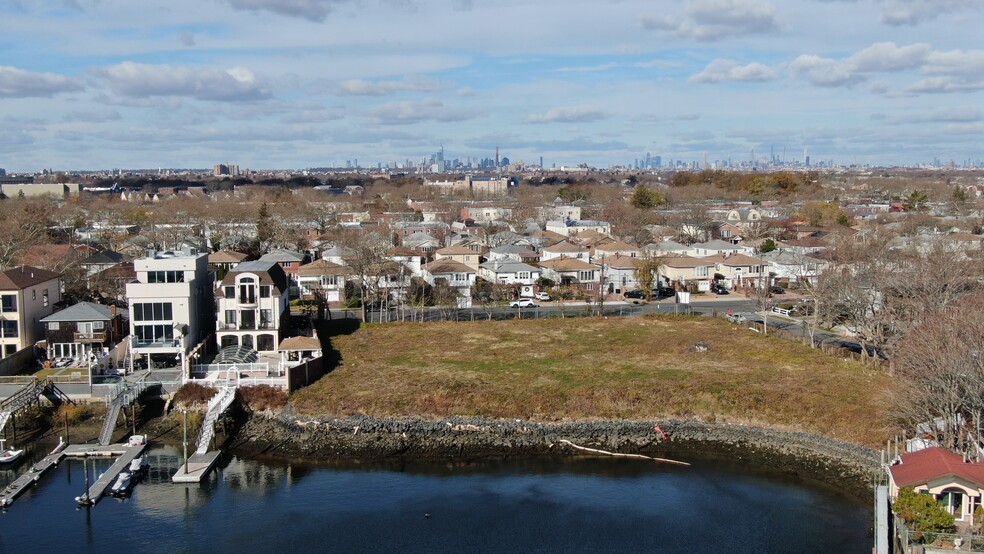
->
126, 249, 215, 369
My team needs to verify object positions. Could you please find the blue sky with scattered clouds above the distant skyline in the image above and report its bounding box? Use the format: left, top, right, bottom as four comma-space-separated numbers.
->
0, 0, 984, 172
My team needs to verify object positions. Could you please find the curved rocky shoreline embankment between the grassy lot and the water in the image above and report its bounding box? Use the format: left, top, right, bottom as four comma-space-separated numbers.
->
225, 407, 879, 498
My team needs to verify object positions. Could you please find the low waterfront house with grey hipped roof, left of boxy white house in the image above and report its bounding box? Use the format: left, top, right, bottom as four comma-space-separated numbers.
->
41, 302, 124, 367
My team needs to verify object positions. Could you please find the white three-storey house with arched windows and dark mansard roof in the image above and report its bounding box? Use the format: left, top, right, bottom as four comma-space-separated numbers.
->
215, 260, 290, 352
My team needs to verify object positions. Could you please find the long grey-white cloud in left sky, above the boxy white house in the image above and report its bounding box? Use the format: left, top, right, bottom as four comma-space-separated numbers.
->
91, 62, 271, 101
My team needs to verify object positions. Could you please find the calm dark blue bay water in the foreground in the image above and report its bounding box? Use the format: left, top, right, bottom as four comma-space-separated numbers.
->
0, 447, 871, 552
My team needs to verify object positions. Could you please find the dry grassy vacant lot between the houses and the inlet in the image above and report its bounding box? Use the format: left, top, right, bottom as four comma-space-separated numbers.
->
292, 316, 888, 445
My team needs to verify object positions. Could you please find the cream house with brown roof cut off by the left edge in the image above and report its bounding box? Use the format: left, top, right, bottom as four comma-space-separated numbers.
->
0, 265, 61, 358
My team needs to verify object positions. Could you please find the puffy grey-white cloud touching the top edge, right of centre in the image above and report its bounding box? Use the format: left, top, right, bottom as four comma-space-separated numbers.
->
641, 0, 779, 42
